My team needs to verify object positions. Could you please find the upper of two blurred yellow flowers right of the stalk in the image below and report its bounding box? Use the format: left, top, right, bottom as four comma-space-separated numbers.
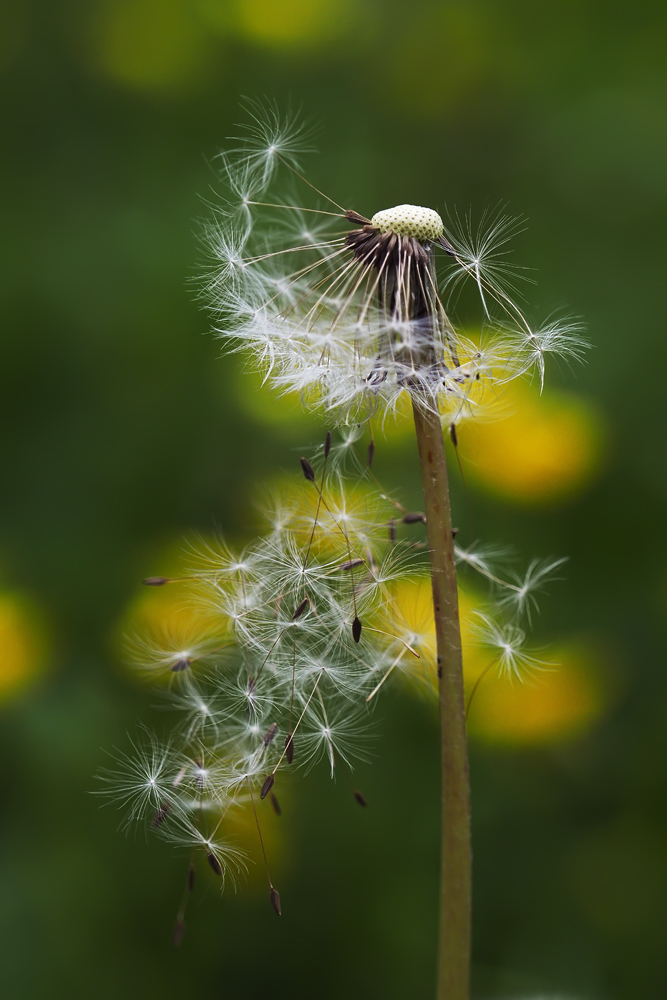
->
458, 381, 603, 503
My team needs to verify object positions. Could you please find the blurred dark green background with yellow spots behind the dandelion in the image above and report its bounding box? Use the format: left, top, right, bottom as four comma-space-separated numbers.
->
0, 0, 667, 1000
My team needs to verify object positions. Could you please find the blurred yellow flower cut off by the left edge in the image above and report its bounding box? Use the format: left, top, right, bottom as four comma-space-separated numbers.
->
0, 591, 49, 701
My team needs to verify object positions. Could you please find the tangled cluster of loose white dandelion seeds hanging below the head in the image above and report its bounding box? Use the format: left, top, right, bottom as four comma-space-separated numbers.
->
102, 427, 559, 940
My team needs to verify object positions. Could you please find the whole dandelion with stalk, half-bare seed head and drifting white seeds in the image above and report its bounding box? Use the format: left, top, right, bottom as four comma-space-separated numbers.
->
100, 104, 583, 1000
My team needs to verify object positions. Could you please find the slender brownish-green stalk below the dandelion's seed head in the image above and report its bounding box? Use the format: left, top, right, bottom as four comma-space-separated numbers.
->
413, 400, 472, 1000
